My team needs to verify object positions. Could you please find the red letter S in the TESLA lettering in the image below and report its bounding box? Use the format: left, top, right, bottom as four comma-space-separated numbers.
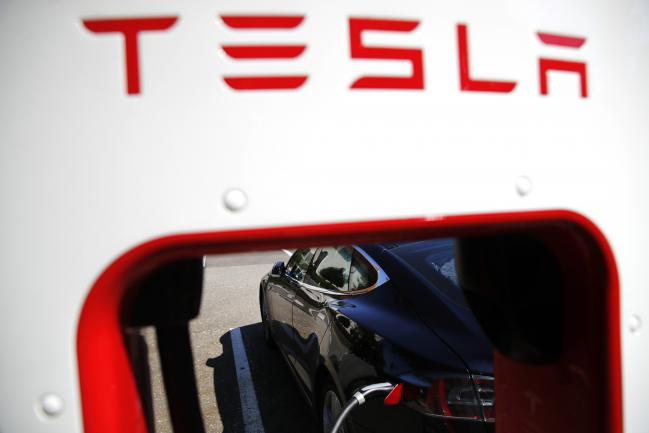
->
349, 18, 424, 90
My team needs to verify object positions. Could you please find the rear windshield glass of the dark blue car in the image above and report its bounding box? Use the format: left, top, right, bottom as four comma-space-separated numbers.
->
392, 239, 468, 308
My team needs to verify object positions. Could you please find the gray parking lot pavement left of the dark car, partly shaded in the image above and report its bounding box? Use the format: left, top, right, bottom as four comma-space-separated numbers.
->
144, 251, 316, 433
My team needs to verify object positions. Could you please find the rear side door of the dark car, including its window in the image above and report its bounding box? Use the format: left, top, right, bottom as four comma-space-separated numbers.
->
293, 246, 353, 391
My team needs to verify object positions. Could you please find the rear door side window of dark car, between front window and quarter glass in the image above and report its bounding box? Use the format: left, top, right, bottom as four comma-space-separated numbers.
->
305, 246, 353, 292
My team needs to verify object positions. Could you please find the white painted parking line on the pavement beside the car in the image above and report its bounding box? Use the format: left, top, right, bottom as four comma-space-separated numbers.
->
230, 328, 265, 433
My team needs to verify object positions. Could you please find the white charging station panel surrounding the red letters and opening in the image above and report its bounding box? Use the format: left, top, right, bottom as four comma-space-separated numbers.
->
0, 0, 649, 433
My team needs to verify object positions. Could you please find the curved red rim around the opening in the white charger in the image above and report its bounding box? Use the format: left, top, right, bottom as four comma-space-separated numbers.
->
77, 210, 623, 433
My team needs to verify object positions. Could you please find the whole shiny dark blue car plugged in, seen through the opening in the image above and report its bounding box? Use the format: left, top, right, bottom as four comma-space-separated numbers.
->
259, 239, 495, 433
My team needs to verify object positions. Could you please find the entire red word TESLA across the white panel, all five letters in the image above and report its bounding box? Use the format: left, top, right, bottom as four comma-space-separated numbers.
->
82, 15, 588, 98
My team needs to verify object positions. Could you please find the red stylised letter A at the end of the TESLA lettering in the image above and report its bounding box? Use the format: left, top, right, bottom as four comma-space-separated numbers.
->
537, 32, 588, 98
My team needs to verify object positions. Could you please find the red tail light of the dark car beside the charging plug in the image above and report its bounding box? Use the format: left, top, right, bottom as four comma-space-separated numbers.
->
403, 376, 496, 422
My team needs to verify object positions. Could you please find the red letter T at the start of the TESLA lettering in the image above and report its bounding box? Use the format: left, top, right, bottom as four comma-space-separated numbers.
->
83, 17, 178, 95
